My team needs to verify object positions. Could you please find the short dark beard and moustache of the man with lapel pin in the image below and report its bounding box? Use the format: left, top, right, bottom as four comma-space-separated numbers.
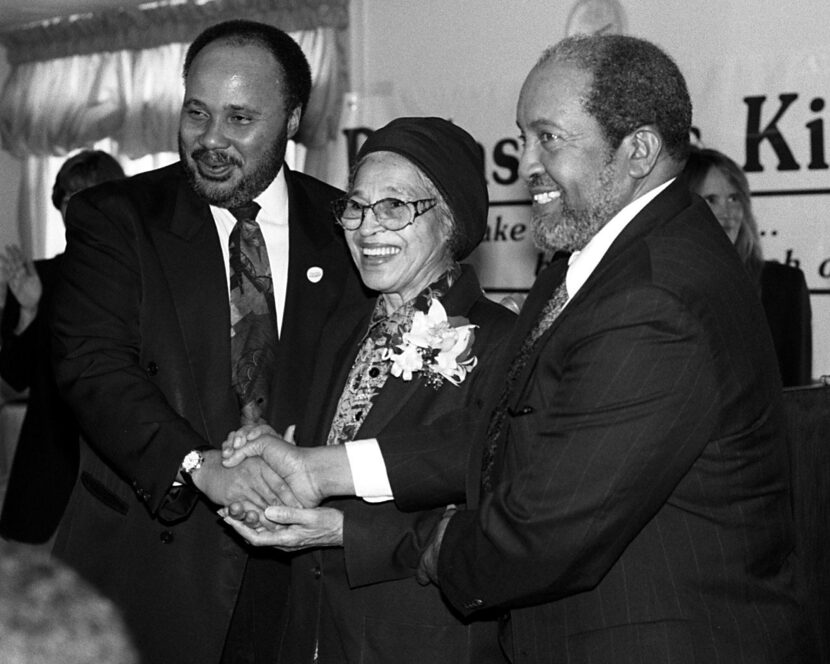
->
179, 133, 288, 208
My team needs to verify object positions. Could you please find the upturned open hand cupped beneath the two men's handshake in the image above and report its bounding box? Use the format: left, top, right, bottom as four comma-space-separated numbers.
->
223, 506, 343, 551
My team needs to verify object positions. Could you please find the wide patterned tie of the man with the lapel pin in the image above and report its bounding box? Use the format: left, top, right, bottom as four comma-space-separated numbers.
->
228, 202, 278, 424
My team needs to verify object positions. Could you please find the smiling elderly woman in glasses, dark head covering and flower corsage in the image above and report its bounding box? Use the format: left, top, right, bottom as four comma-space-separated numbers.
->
227, 118, 513, 664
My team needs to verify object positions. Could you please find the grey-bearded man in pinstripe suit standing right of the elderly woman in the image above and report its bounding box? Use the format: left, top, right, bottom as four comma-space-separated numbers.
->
224, 36, 810, 664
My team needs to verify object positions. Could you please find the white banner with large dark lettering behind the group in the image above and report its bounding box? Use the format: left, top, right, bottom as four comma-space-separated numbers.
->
339, 54, 830, 376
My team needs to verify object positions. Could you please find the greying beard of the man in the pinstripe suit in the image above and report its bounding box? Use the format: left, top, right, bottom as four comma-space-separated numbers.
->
531, 159, 622, 254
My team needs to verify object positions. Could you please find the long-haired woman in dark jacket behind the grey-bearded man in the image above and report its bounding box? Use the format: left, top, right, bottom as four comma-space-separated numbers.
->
685, 148, 813, 386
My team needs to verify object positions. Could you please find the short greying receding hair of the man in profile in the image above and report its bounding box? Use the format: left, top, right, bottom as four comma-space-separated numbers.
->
536, 35, 692, 162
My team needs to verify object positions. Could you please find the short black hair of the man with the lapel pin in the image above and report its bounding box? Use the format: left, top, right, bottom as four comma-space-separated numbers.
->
182, 20, 311, 112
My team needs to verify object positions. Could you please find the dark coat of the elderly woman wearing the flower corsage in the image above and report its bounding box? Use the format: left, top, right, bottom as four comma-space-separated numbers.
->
280, 266, 514, 664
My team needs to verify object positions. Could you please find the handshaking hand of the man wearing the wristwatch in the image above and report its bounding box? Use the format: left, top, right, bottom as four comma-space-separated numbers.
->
191, 450, 301, 510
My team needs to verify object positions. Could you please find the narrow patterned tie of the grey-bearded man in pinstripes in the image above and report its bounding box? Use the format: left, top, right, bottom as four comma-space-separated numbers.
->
481, 279, 568, 492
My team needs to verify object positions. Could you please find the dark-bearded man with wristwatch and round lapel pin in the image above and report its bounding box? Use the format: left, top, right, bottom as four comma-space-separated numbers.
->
49, 21, 364, 664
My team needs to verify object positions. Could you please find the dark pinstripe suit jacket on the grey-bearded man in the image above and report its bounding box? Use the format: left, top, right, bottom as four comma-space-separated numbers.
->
422, 181, 800, 664
